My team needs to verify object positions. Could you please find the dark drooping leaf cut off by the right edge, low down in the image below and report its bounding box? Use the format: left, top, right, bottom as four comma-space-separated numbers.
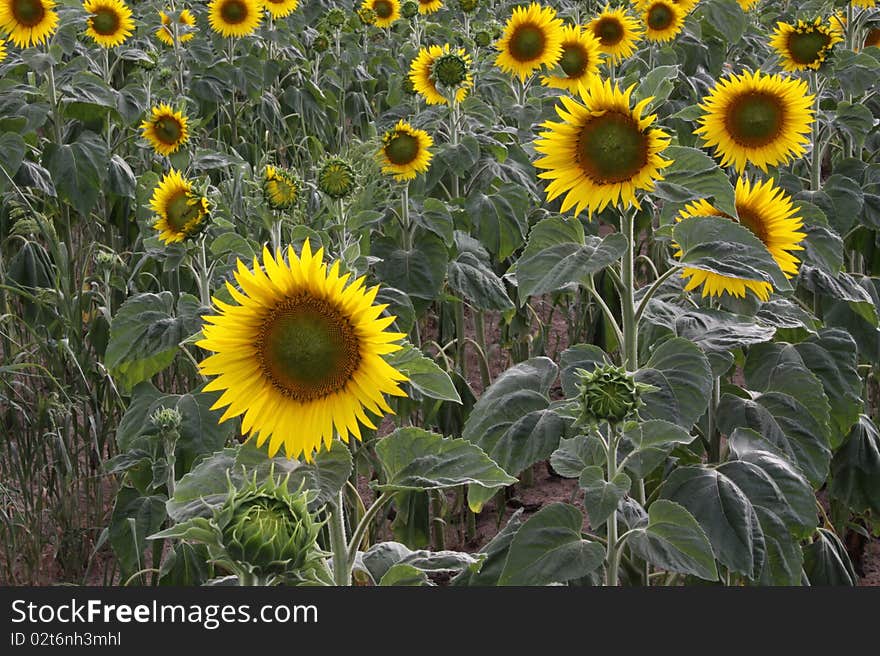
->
831, 415, 880, 516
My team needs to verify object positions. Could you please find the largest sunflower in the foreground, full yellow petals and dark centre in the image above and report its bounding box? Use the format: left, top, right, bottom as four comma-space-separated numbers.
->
198, 241, 406, 461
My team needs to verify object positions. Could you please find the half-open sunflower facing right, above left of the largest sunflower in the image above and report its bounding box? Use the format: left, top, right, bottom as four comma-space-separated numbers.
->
150, 169, 208, 244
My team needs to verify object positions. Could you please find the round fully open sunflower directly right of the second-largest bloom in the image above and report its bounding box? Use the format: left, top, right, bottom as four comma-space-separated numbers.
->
694, 71, 813, 172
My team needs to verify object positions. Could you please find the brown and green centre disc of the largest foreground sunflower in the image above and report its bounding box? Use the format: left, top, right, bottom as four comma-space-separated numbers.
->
257, 294, 361, 401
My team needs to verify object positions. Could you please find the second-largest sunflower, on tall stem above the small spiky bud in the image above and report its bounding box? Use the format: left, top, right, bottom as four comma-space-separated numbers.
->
535, 76, 672, 215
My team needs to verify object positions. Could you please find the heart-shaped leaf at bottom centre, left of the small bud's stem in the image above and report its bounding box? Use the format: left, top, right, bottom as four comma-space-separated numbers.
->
498, 503, 605, 585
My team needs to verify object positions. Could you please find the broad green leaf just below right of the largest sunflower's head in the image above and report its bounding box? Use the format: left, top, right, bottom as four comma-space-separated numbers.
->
376, 428, 516, 490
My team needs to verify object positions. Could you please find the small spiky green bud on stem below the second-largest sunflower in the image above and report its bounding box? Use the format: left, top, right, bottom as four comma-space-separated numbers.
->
576, 364, 654, 425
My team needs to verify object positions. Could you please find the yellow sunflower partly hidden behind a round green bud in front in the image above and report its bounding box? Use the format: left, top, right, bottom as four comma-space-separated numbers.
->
409, 43, 474, 105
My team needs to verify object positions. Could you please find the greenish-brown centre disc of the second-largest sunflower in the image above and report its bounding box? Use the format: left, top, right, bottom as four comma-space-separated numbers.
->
577, 112, 648, 184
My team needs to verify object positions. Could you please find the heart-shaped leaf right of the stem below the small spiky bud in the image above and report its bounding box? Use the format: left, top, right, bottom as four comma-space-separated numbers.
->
627, 499, 718, 581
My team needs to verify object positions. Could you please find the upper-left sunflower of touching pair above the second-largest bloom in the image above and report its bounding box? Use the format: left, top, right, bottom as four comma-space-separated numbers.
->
495, 2, 562, 80
